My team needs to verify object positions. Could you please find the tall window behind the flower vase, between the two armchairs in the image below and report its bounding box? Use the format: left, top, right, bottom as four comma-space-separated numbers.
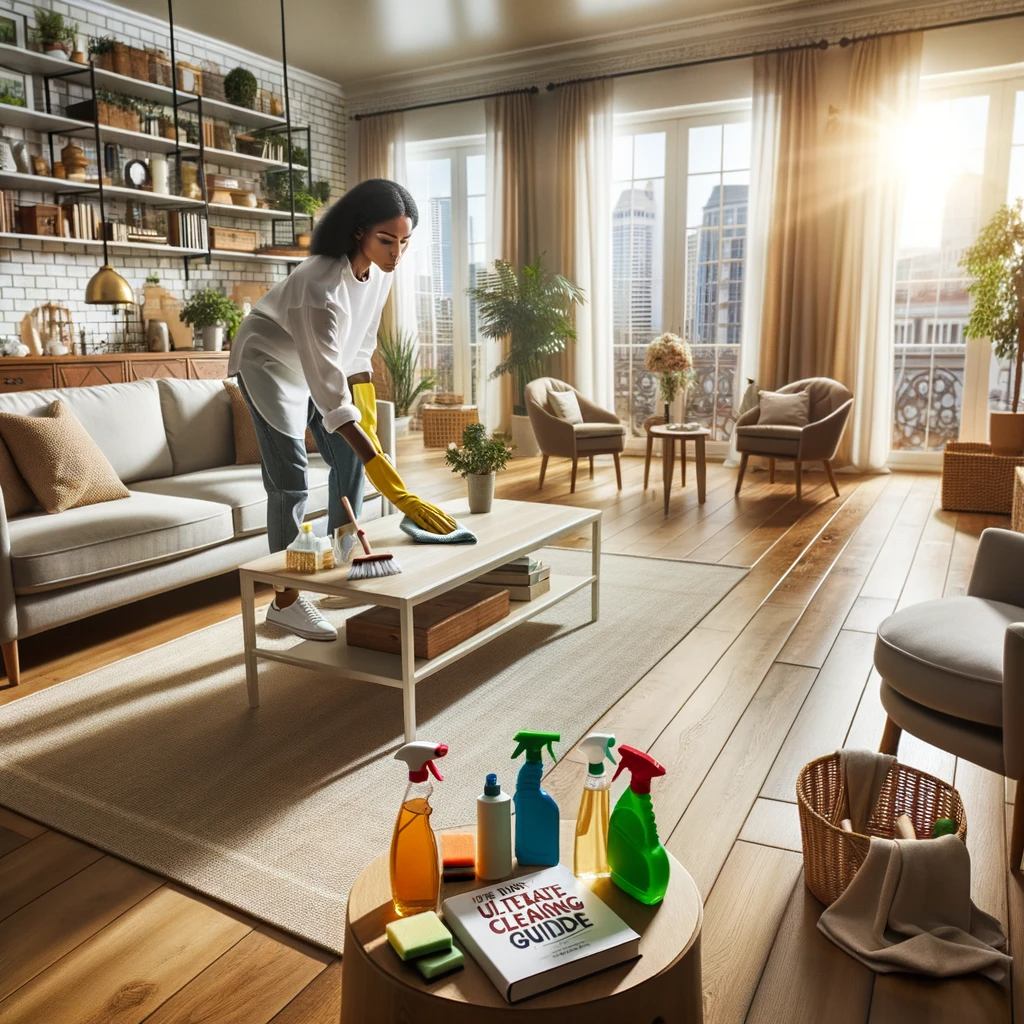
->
611, 112, 750, 440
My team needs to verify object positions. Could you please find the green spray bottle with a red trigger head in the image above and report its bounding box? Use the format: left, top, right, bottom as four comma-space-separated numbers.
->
608, 744, 669, 904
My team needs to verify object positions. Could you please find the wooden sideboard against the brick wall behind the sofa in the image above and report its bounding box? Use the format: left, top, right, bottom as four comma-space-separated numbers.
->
0, 349, 228, 393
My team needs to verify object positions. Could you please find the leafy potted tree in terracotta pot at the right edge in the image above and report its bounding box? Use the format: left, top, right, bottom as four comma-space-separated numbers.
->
961, 199, 1024, 455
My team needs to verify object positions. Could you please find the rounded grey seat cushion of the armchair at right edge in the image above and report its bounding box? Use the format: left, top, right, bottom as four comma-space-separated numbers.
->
874, 597, 1024, 726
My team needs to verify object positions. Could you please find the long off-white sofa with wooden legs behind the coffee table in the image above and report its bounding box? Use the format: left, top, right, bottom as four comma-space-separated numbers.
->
0, 379, 394, 685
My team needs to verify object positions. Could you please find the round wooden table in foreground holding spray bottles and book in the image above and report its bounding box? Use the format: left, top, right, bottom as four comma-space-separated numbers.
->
341, 821, 703, 1024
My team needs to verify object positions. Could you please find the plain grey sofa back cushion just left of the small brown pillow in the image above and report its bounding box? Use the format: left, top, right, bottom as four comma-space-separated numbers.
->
157, 377, 234, 476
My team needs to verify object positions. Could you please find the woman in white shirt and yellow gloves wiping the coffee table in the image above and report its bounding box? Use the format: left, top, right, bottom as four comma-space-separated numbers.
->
234, 178, 456, 640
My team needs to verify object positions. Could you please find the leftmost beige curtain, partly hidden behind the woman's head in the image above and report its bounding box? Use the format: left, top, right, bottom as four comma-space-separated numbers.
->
355, 114, 416, 399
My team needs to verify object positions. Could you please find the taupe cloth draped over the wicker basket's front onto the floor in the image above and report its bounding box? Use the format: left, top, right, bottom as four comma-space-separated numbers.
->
818, 836, 1013, 982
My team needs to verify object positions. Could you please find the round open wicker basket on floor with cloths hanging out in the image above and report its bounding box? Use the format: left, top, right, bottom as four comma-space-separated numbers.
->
797, 754, 967, 906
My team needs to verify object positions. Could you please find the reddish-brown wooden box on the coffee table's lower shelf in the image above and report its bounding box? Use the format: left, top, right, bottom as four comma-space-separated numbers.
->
345, 583, 509, 658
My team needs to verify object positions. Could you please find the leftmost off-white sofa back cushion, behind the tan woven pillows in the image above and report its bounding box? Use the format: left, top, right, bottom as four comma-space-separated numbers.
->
0, 380, 174, 483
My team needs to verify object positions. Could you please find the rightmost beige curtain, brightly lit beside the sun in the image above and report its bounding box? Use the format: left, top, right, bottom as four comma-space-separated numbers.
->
825, 32, 923, 470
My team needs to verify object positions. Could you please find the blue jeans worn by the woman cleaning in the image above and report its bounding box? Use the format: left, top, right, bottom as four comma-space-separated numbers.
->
238, 376, 365, 551
